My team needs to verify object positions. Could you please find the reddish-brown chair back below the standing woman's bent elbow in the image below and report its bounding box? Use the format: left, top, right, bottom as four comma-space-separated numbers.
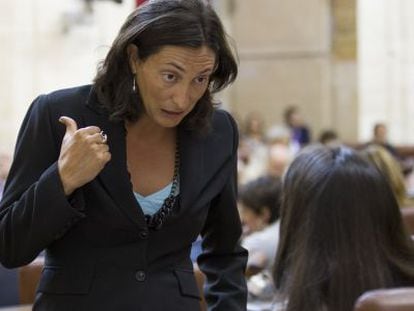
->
19, 257, 44, 304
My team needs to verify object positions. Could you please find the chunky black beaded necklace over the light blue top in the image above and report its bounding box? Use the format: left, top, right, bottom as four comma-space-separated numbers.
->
145, 137, 180, 230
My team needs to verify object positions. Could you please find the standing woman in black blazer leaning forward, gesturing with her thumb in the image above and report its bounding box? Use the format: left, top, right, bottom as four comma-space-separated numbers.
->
0, 0, 247, 311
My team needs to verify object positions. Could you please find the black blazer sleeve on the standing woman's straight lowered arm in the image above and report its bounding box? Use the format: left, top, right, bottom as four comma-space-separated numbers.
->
197, 114, 248, 311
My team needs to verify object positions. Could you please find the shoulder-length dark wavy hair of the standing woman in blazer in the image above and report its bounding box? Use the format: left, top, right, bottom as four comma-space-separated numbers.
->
94, 0, 237, 133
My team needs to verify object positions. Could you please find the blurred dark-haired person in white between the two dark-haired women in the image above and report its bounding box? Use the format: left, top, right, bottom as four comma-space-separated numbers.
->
238, 176, 281, 276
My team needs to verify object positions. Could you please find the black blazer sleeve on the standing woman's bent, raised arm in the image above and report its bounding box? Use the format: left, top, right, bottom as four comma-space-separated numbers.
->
0, 95, 84, 268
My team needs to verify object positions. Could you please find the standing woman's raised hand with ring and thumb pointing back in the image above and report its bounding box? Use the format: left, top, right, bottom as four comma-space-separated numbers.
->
58, 117, 111, 195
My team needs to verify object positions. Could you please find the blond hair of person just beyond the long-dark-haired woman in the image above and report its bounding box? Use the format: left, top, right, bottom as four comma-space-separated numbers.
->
361, 145, 414, 207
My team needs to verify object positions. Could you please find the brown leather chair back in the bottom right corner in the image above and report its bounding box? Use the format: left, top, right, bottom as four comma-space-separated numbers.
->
354, 287, 414, 311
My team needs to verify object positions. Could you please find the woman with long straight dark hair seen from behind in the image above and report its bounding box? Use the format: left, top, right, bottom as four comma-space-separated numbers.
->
274, 146, 414, 311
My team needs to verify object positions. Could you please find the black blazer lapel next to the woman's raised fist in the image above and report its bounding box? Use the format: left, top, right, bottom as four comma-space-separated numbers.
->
85, 91, 146, 227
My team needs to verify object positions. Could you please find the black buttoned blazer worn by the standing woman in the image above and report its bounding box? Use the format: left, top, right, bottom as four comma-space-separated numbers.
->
0, 86, 247, 311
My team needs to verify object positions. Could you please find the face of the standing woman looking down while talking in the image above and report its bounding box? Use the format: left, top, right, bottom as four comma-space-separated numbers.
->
128, 45, 216, 127
